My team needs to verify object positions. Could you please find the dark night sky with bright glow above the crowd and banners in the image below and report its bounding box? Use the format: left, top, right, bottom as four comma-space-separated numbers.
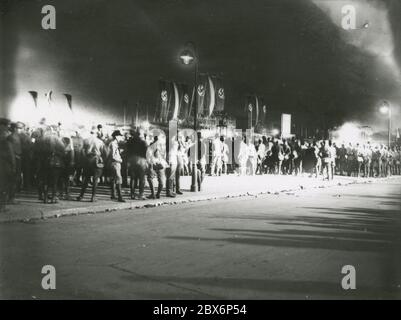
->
0, 0, 401, 128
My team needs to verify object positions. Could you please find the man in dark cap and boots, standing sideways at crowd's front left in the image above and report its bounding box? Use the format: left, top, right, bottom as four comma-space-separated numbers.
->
110, 130, 125, 202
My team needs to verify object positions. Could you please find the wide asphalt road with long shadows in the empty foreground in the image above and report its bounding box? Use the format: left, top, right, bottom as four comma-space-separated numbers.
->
0, 179, 401, 299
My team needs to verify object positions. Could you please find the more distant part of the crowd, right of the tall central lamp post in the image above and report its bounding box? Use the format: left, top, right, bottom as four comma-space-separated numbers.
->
210, 136, 401, 180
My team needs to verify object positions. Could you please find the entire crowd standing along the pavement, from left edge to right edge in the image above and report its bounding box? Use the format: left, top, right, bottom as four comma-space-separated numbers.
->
0, 119, 401, 212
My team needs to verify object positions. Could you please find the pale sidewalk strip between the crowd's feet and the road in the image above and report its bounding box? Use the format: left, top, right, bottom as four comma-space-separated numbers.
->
0, 175, 382, 223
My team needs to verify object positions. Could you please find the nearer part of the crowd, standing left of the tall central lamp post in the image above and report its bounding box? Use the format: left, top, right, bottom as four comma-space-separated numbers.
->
0, 119, 204, 208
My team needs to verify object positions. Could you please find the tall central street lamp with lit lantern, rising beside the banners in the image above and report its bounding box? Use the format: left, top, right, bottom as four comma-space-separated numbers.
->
180, 42, 199, 192
